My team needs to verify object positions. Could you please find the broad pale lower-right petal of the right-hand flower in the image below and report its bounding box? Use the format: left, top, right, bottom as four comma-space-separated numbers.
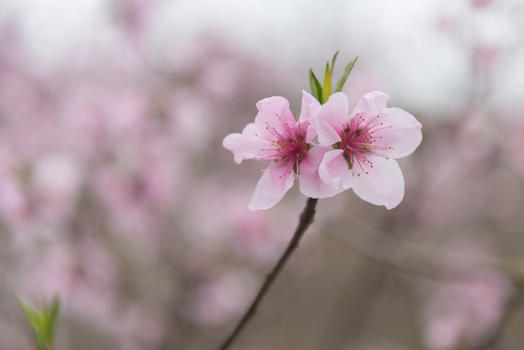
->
353, 156, 404, 209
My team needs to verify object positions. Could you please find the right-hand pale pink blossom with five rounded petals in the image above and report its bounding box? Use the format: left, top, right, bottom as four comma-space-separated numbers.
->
317, 91, 422, 209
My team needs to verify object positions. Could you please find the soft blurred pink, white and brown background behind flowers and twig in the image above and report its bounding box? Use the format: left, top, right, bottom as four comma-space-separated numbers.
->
0, 0, 524, 350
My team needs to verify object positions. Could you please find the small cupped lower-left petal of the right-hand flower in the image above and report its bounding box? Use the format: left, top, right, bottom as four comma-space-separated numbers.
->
318, 149, 353, 190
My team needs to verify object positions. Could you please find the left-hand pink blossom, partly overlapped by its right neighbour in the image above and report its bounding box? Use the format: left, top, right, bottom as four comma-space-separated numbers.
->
223, 91, 342, 210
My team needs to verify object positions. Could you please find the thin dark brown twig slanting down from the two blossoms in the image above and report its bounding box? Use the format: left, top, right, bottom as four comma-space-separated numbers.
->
219, 198, 317, 350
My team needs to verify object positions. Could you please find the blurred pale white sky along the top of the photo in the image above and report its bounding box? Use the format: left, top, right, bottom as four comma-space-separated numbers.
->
0, 0, 524, 113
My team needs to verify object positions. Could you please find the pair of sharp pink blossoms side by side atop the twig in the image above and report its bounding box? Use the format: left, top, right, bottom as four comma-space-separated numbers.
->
223, 91, 422, 210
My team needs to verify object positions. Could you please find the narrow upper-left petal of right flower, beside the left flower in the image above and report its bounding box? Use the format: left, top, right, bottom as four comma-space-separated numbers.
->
317, 92, 349, 146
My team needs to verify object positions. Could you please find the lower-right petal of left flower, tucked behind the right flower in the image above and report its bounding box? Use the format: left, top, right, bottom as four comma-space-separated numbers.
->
298, 146, 344, 198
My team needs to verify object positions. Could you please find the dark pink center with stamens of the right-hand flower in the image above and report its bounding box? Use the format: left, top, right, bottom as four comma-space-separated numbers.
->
333, 114, 393, 176
